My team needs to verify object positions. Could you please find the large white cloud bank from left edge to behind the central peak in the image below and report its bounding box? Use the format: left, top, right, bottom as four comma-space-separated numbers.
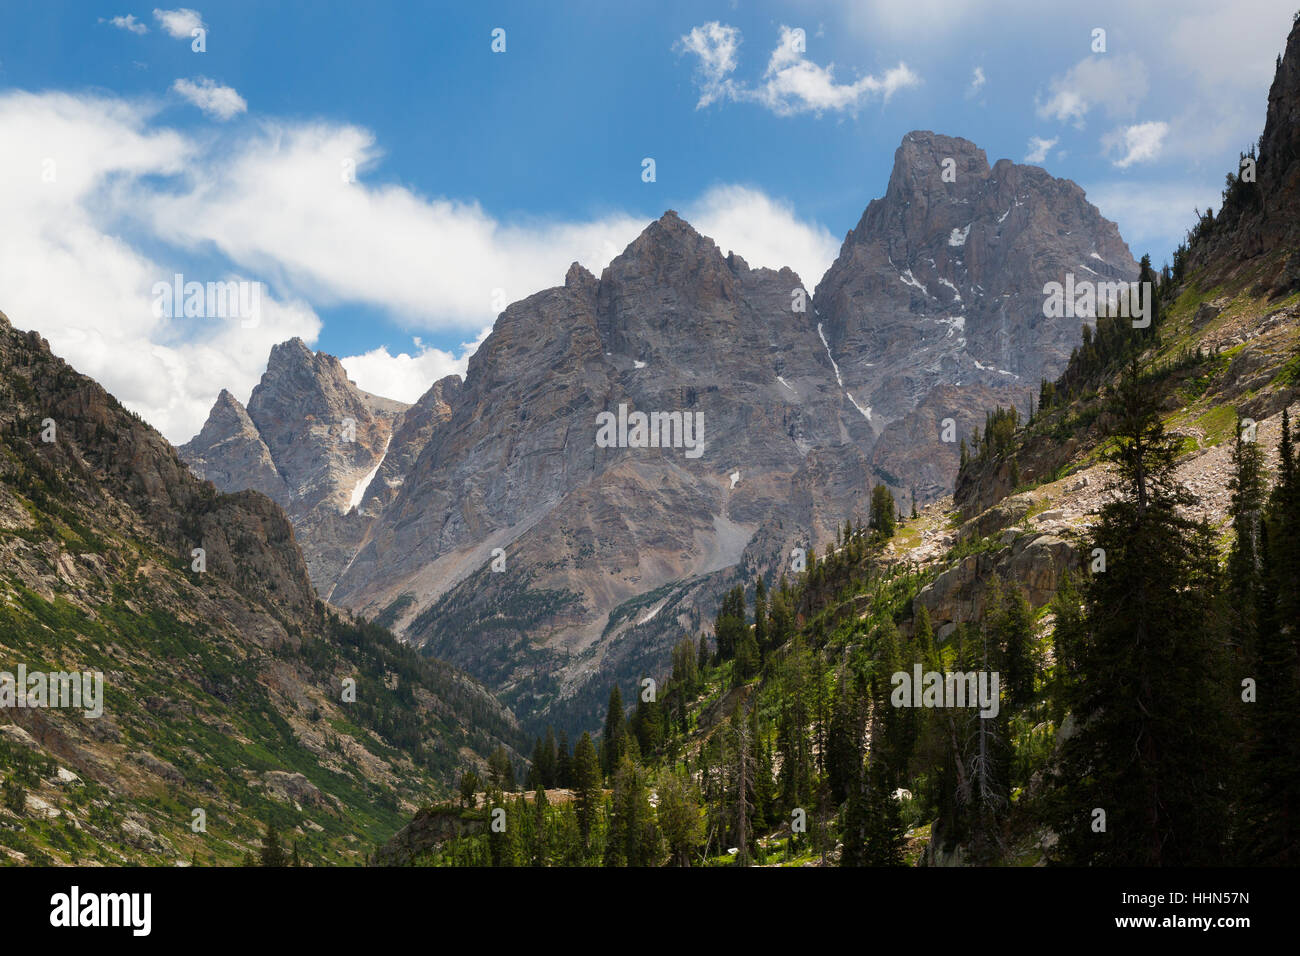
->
0, 91, 836, 442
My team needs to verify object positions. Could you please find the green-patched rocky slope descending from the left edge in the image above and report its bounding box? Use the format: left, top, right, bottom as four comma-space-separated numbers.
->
0, 315, 520, 865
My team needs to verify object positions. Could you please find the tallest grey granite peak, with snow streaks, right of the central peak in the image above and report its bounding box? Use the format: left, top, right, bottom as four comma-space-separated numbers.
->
815, 131, 1138, 499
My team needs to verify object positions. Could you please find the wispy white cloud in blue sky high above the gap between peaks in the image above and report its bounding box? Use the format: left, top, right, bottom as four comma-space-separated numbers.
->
679, 21, 920, 116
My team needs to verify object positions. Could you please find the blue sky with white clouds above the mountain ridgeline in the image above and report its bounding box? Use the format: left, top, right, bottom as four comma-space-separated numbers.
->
0, 0, 1297, 444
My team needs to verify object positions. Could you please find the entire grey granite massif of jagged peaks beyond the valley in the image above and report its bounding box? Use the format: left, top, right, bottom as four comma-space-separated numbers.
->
182, 133, 1136, 727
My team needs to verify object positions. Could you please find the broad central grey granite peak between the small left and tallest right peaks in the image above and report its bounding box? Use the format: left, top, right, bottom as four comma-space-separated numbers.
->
333, 212, 868, 728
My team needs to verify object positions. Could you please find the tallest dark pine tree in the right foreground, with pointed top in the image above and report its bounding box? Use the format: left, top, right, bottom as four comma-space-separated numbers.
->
1053, 359, 1229, 866
